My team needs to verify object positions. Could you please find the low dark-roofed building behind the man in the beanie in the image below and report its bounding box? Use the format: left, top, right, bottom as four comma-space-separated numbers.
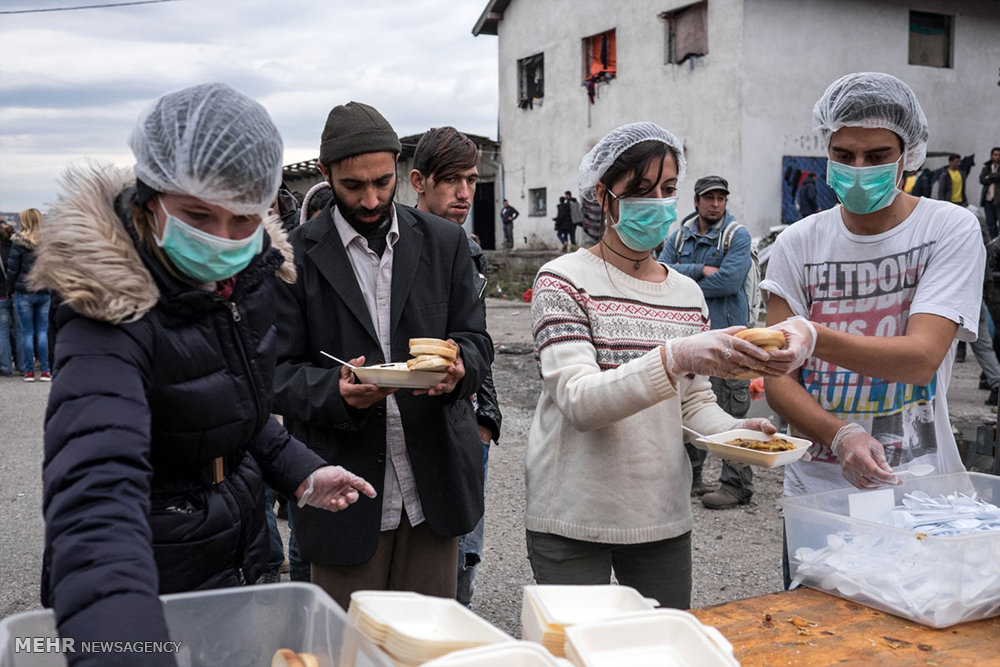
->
282, 132, 503, 250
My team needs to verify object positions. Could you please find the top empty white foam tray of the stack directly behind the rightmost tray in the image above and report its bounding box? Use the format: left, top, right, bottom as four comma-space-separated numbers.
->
524, 585, 657, 627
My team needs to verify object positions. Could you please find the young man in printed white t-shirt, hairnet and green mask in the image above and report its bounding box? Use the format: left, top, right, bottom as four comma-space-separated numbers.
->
761, 72, 985, 495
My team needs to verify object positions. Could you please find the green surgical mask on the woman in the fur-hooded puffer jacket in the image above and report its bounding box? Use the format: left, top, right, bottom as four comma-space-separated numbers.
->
156, 199, 264, 282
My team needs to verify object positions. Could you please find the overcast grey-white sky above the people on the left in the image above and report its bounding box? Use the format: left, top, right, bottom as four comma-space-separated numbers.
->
0, 0, 497, 212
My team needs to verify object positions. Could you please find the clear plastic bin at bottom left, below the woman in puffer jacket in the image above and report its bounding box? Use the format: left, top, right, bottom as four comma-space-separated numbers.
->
0, 583, 392, 667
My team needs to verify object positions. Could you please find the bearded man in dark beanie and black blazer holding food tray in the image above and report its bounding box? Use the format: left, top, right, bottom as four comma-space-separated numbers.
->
275, 102, 493, 609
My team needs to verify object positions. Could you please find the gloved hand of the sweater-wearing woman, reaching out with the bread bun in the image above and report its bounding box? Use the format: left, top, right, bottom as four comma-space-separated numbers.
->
664, 327, 776, 382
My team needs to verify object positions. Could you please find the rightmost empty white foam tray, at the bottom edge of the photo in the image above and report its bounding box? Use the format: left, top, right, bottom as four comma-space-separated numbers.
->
566, 609, 740, 667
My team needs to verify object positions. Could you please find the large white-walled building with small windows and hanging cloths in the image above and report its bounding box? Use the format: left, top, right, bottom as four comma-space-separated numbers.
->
473, 0, 1000, 247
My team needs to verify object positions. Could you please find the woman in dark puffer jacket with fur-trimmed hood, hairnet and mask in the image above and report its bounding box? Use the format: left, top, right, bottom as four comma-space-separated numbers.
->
31, 84, 374, 665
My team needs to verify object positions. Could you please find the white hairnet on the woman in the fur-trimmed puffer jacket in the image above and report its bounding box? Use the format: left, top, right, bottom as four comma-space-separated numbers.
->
129, 83, 282, 215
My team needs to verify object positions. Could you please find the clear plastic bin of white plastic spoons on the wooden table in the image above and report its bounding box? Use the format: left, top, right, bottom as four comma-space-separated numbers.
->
782, 472, 1000, 628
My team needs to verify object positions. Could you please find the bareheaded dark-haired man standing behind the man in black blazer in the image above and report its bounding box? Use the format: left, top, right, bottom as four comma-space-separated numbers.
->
410, 127, 501, 606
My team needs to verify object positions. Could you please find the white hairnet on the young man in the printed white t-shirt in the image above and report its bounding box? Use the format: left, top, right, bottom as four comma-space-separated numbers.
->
813, 72, 928, 171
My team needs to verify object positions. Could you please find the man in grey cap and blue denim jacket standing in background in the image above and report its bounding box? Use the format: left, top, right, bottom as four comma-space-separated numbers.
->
659, 176, 753, 509
